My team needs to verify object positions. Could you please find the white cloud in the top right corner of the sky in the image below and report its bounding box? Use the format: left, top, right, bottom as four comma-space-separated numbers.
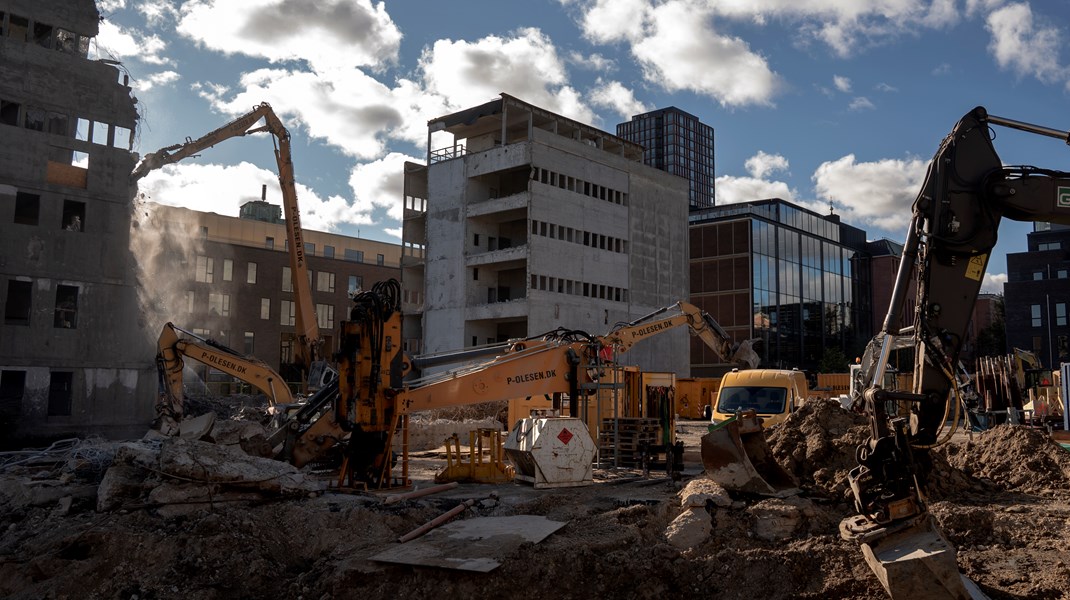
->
985, 2, 1067, 83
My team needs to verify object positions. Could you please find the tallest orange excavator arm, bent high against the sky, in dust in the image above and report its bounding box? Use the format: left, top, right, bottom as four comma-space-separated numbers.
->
131, 103, 323, 369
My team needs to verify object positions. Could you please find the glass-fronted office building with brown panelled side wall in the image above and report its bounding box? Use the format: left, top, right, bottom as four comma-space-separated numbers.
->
688, 199, 872, 375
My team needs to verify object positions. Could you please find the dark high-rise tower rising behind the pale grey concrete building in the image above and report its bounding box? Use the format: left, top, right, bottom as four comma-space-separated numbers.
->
616, 106, 716, 211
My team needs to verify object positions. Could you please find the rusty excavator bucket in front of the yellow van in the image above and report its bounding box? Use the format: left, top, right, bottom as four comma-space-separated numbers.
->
702, 411, 799, 497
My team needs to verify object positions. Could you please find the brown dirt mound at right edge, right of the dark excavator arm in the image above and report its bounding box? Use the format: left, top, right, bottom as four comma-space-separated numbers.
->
944, 425, 1070, 493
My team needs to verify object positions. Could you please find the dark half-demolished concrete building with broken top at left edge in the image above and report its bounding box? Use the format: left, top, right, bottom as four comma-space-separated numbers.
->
0, 0, 156, 444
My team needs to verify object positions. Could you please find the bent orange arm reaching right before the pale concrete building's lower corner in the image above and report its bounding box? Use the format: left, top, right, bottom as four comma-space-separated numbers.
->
602, 302, 759, 369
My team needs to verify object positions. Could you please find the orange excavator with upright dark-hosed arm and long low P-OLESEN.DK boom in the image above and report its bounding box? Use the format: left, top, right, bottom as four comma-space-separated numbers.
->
269, 288, 756, 488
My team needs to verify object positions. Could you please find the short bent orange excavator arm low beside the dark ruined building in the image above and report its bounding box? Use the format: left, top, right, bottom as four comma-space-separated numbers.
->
156, 323, 293, 434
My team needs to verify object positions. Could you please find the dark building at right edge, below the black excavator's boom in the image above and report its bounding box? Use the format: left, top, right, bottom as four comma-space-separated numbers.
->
1004, 222, 1070, 369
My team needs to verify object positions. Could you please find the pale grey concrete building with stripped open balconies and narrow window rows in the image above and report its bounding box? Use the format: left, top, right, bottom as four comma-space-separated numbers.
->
402, 94, 688, 374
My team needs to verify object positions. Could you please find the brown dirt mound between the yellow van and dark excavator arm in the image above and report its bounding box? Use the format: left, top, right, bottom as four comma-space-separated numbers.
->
766, 399, 869, 499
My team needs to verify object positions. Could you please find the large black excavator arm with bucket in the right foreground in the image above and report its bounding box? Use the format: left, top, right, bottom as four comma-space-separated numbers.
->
840, 107, 1070, 600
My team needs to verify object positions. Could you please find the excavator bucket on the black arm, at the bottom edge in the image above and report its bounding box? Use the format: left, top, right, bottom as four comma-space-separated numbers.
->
840, 514, 988, 600
